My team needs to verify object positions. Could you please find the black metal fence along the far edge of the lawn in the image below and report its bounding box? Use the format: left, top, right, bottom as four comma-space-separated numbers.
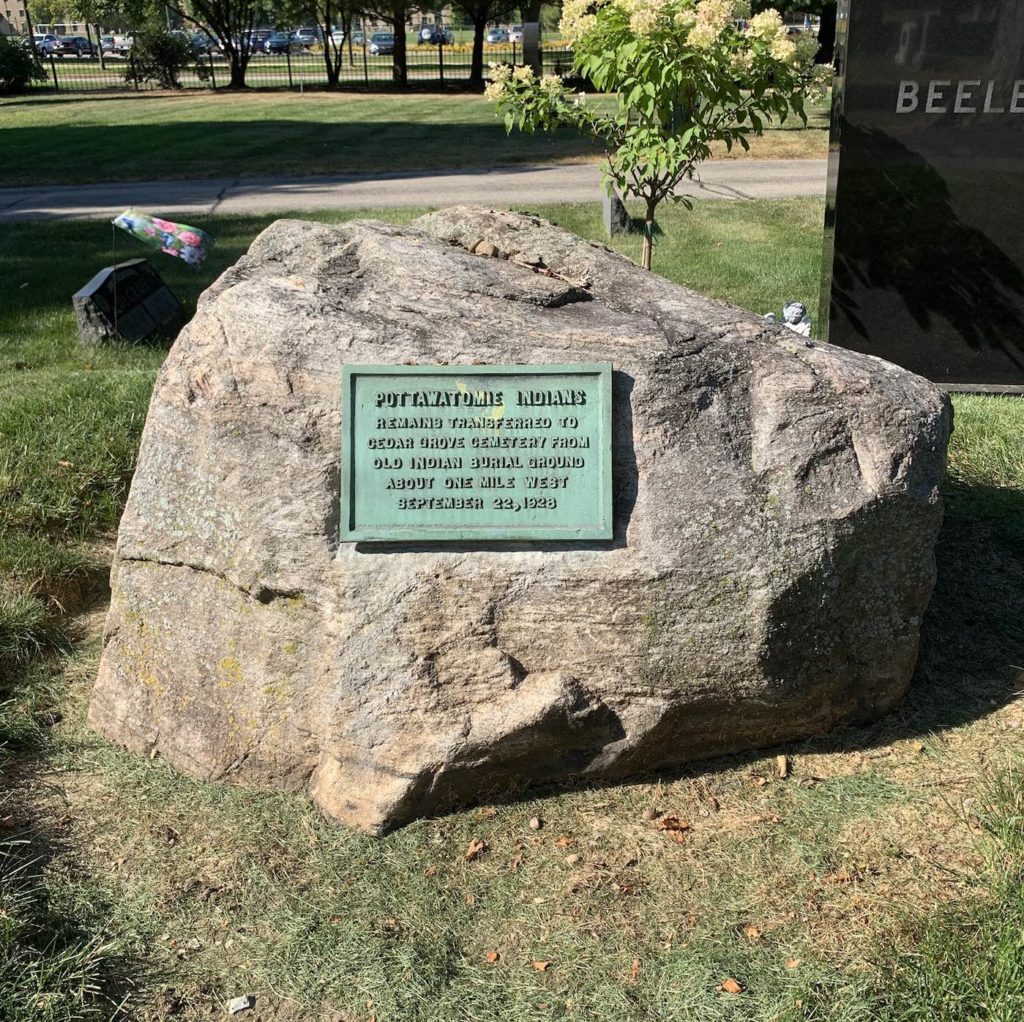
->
37, 43, 572, 92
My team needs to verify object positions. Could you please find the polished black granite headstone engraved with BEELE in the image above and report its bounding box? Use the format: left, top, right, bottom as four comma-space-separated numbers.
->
822, 0, 1024, 389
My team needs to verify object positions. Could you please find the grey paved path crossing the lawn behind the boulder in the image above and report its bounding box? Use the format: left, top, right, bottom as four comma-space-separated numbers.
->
0, 160, 825, 221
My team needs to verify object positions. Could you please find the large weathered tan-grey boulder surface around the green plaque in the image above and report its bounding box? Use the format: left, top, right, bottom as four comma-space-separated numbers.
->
90, 208, 950, 832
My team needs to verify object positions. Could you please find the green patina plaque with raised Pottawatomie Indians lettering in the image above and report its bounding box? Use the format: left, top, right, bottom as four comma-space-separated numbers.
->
341, 363, 612, 542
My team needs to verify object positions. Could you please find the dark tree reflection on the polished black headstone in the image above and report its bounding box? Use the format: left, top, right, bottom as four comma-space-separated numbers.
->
831, 124, 1024, 368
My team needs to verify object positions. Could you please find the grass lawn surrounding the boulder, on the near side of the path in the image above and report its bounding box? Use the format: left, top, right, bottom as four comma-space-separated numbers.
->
0, 200, 1024, 1022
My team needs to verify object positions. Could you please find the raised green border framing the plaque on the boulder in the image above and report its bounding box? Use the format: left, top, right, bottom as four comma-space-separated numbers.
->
339, 363, 614, 544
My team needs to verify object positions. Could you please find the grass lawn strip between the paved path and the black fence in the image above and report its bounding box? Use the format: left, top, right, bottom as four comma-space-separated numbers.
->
0, 91, 827, 186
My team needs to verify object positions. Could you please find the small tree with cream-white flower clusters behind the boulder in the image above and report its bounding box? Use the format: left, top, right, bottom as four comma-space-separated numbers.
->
484, 0, 831, 269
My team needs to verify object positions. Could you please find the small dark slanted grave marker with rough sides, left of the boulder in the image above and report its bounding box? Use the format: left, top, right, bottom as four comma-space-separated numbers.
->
72, 259, 184, 344
